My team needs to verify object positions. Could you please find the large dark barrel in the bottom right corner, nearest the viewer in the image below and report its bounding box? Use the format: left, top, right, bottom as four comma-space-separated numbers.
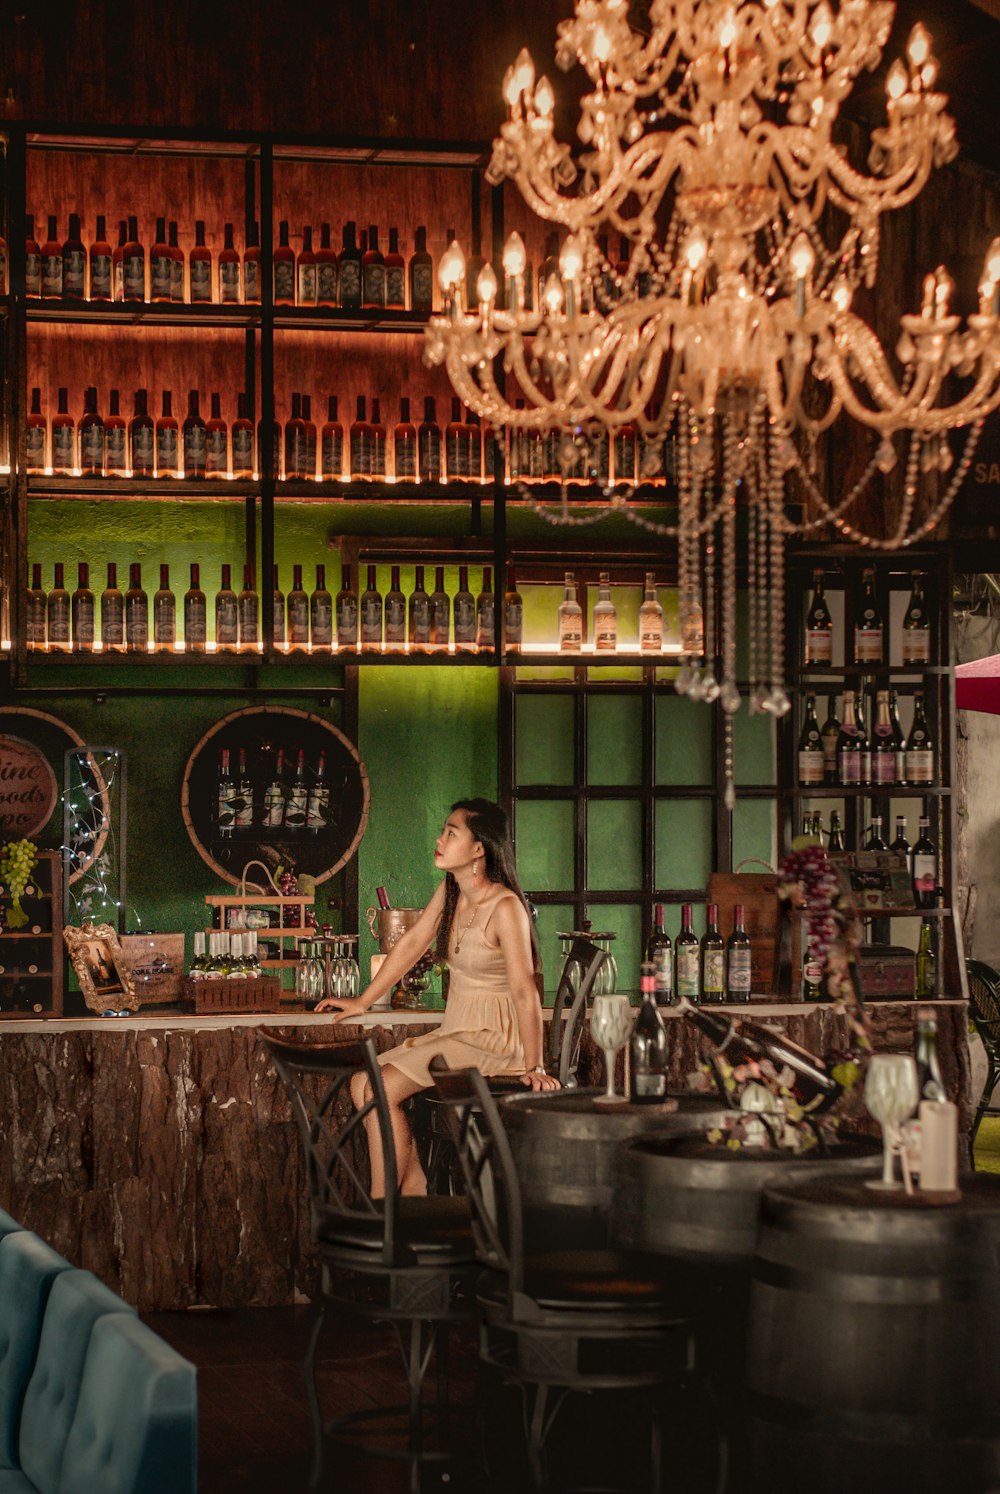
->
747, 1174, 1000, 1494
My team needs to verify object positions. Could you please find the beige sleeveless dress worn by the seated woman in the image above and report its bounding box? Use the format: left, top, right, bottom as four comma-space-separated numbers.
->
378, 887, 525, 1089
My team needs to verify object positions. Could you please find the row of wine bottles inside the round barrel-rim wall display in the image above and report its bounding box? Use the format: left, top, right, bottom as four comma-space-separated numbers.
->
215, 747, 330, 838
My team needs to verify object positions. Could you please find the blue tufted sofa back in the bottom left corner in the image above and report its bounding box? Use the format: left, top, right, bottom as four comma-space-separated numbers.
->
0, 1212, 197, 1494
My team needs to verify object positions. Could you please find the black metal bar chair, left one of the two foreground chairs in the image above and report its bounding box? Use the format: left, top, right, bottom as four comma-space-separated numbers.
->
262, 1034, 475, 1488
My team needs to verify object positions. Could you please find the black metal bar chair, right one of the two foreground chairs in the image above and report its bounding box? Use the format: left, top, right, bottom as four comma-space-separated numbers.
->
430, 1059, 694, 1494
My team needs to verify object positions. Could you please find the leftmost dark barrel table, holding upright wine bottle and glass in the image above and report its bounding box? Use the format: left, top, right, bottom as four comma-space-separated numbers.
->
501, 1089, 725, 1252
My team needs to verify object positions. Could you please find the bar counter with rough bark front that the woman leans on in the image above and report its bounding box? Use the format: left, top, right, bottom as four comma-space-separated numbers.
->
0, 1001, 972, 1312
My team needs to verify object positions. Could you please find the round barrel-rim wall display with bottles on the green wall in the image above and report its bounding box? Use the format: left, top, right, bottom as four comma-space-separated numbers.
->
181, 705, 369, 884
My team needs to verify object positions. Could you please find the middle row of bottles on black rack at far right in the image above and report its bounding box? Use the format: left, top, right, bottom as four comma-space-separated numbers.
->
798, 690, 936, 787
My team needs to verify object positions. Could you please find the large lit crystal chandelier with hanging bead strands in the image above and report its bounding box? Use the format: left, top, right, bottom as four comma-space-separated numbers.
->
425, 0, 1000, 794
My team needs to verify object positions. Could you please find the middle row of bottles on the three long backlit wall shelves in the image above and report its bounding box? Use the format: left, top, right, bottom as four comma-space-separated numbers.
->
25, 385, 665, 483
